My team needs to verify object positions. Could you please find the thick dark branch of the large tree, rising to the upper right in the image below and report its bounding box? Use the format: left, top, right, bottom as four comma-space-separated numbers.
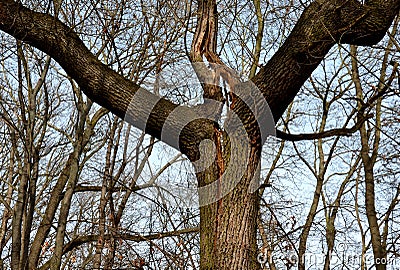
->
253, 0, 400, 120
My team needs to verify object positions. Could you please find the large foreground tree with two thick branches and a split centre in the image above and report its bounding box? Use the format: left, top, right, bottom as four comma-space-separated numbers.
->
0, 0, 400, 269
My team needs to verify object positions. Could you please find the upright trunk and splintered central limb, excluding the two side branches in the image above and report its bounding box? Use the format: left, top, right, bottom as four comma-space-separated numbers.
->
190, 0, 274, 269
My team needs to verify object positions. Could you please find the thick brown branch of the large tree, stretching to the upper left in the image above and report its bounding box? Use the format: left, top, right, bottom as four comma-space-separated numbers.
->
0, 0, 213, 159
